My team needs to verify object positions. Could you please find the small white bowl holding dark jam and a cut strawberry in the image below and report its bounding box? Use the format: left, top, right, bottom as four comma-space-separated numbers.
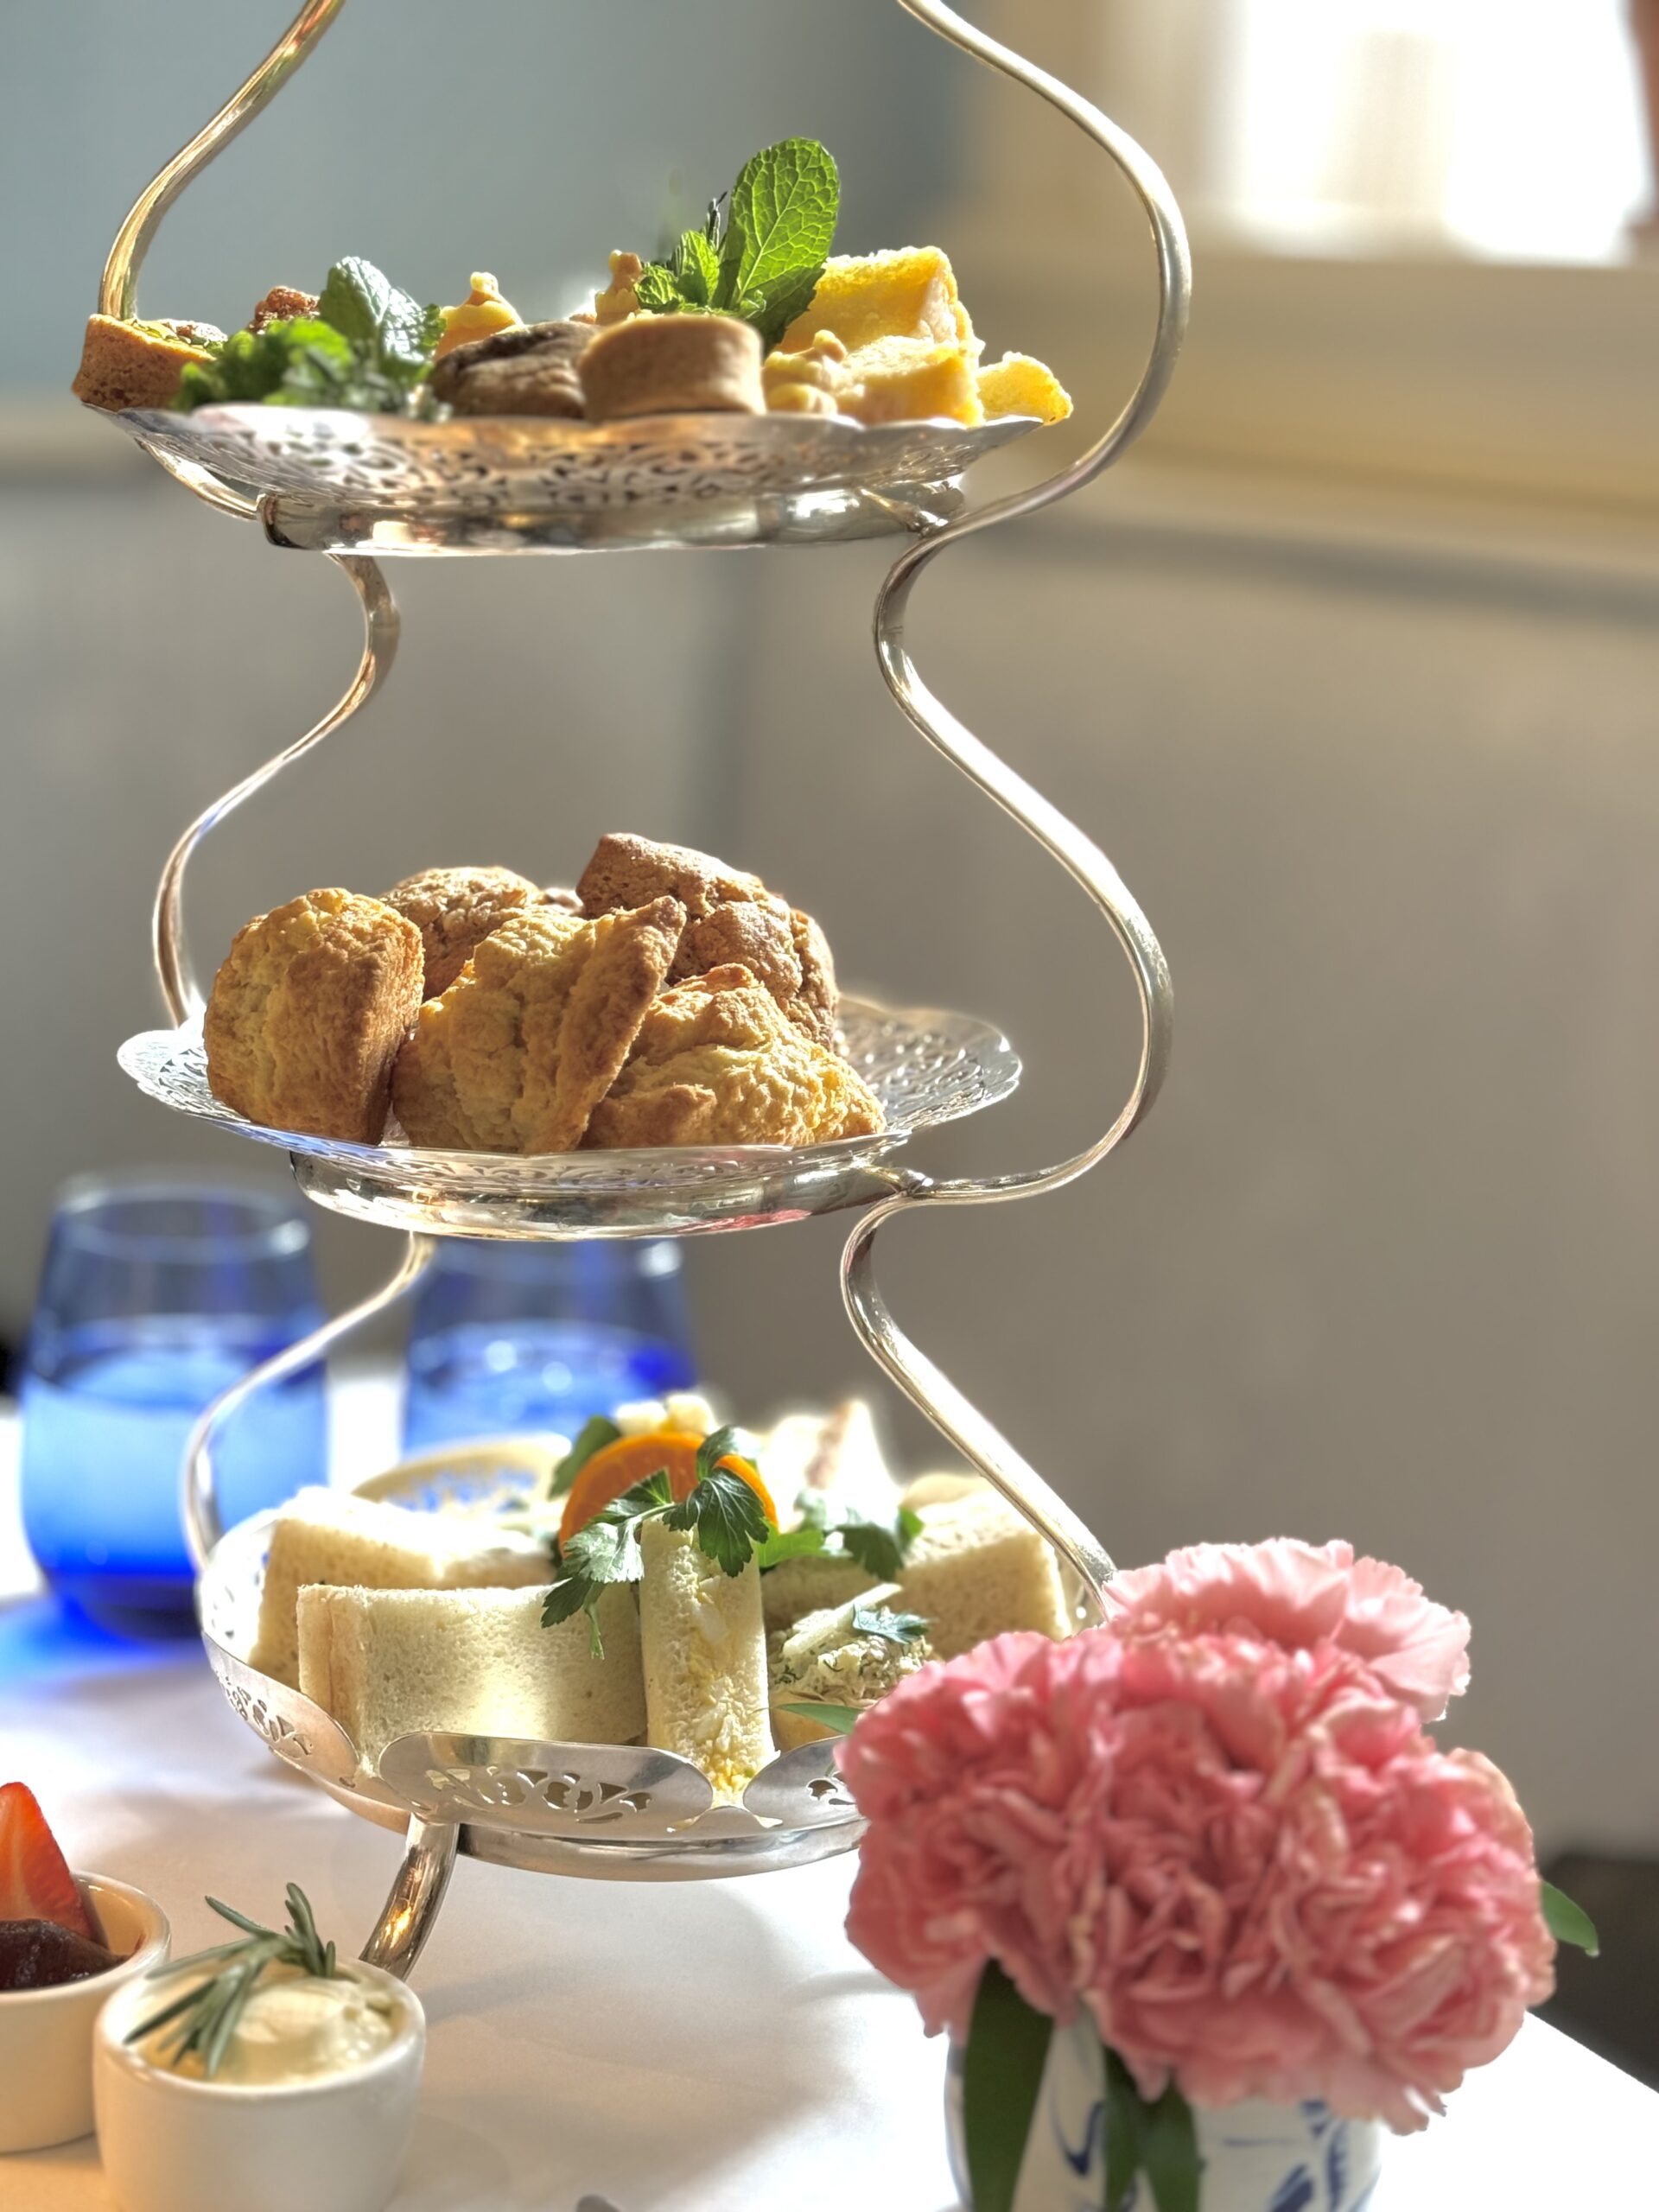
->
0, 1873, 168, 2150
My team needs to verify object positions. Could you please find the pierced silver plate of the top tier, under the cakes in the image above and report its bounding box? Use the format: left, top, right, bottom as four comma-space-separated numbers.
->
113, 407, 1042, 553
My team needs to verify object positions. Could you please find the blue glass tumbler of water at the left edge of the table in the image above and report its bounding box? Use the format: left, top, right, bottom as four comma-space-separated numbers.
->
20, 1174, 327, 1626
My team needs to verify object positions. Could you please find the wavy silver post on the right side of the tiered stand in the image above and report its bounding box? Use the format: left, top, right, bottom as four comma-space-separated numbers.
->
841, 0, 1192, 1611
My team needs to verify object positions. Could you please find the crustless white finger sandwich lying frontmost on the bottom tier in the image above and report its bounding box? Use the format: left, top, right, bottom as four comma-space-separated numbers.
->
299, 1584, 646, 1767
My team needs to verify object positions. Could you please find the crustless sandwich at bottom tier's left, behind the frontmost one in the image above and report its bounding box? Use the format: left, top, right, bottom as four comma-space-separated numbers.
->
248, 1489, 553, 1690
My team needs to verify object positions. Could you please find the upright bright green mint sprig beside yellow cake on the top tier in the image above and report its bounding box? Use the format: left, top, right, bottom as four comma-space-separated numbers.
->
635, 139, 841, 352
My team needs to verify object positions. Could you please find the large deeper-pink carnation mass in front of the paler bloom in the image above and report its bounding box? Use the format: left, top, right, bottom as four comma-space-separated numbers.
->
842, 1546, 1555, 2128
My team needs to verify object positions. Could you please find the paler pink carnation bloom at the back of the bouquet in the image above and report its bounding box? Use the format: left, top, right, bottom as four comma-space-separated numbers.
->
1109, 1537, 1469, 1721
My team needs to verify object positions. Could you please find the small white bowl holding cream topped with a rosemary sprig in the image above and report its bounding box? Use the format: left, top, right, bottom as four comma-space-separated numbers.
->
93, 1964, 427, 2212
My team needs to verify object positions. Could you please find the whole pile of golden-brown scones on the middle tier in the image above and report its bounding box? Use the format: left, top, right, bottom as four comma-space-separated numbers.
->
204, 836, 882, 1153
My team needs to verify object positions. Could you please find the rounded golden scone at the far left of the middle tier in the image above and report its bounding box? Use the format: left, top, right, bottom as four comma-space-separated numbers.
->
201, 892, 420, 1144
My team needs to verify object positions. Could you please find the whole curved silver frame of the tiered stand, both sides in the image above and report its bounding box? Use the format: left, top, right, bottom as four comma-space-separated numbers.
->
99, 0, 1192, 1974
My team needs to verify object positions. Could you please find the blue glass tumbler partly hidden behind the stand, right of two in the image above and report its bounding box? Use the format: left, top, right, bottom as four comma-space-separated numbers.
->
403, 1236, 696, 1451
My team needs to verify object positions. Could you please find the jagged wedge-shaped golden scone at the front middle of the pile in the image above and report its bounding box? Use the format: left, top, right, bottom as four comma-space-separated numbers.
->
391, 898, 686, 1153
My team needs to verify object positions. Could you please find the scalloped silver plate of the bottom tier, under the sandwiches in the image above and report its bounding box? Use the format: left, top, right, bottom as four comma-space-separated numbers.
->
197, 1446, 862, 1883
